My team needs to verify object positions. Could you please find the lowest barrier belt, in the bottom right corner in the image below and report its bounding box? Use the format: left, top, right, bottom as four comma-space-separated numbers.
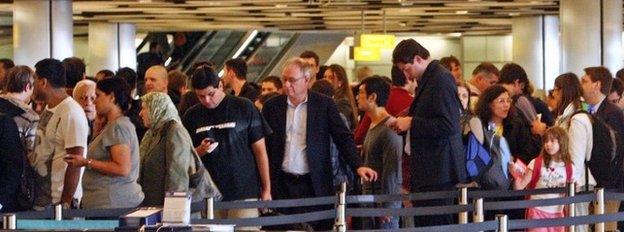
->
507, 212, 624, 230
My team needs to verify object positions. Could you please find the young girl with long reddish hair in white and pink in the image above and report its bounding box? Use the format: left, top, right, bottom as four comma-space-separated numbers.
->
514, 127, 572, 232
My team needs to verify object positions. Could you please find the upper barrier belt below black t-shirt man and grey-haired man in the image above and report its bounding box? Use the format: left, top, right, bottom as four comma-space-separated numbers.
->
214, 196, 338, 209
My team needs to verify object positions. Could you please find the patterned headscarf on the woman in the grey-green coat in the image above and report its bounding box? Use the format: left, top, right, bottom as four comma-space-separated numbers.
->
139, 92, 181, 155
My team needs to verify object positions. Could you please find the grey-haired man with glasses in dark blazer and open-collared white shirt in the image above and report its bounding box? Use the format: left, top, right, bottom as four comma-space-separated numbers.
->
262, 58, 377, 230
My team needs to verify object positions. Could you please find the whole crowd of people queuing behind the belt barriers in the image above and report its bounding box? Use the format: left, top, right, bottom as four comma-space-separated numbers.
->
0, 39, 624, 231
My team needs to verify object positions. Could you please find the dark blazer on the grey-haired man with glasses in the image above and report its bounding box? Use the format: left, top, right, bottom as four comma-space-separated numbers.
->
262, 91, 362, 199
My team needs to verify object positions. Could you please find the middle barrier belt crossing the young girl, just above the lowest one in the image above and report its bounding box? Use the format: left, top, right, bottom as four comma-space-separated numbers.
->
483, 193, 596, 210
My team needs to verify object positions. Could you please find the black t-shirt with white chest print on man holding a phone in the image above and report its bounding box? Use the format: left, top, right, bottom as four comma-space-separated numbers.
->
182, 95, 271, 201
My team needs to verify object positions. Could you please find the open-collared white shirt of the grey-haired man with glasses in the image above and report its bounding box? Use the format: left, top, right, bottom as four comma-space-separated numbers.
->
282, 97, 310, 175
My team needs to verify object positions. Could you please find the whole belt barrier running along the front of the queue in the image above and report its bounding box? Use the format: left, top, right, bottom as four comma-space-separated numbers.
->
3, 188, 624, 231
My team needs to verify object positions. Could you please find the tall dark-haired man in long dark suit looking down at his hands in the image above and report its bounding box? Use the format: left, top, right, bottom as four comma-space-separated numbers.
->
389, 39, 466, 226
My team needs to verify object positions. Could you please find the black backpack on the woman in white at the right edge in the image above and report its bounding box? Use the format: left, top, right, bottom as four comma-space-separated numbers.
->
573, 111, 624, 190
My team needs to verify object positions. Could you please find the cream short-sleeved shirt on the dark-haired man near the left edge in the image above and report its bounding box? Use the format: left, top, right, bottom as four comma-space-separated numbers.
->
33, 97, 89, 203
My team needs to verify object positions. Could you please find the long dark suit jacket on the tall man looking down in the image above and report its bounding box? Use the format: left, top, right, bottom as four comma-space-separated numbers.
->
408, 60, 466, 192
